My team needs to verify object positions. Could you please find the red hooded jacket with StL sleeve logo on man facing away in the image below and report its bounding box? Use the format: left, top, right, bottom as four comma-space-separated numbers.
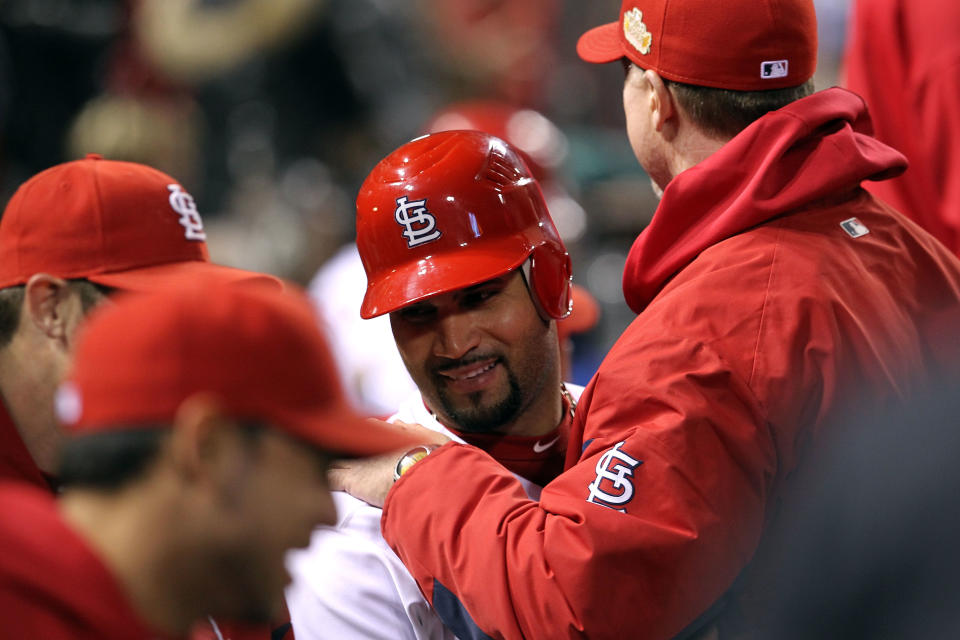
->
383, 89, 960, 638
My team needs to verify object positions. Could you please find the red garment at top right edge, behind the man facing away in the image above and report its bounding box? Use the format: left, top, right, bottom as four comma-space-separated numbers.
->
845, 0, 960, 255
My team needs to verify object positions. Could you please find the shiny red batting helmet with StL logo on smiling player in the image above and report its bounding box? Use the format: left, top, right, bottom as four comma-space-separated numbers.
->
357, 131, 571, 318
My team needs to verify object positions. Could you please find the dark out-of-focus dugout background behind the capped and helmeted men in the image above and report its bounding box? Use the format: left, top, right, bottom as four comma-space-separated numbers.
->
0, 0, 848, 383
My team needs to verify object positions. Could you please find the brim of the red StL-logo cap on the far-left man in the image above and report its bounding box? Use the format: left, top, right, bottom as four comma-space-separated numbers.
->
86, 260, 284, 293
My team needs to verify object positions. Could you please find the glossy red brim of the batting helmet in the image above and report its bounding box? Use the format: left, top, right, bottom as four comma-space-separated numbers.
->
360, 239, 532, 318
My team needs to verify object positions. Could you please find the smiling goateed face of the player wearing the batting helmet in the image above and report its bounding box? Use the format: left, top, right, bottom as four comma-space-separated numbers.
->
390, 271, 559, 433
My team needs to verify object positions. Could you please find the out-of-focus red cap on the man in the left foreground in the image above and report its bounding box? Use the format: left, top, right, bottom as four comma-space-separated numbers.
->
57, 283, 417, 456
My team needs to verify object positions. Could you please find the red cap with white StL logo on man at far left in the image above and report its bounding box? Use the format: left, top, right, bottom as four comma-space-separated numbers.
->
0, 154, 280, 291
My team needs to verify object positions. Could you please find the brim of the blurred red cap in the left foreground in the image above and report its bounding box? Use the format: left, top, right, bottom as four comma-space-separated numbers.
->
286, 405, 424, 457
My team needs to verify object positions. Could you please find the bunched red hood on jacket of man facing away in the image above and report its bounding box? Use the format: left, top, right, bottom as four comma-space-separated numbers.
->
623, 88, 907, 313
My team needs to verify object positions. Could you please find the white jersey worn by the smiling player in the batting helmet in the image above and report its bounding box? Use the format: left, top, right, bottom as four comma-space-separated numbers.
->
286, 384, 583, 640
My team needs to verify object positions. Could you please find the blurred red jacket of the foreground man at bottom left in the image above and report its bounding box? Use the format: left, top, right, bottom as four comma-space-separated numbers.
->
0, 484, 160, 640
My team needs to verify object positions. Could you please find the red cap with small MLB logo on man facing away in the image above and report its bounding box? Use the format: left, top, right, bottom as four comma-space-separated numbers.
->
577, 0, 817, 91
